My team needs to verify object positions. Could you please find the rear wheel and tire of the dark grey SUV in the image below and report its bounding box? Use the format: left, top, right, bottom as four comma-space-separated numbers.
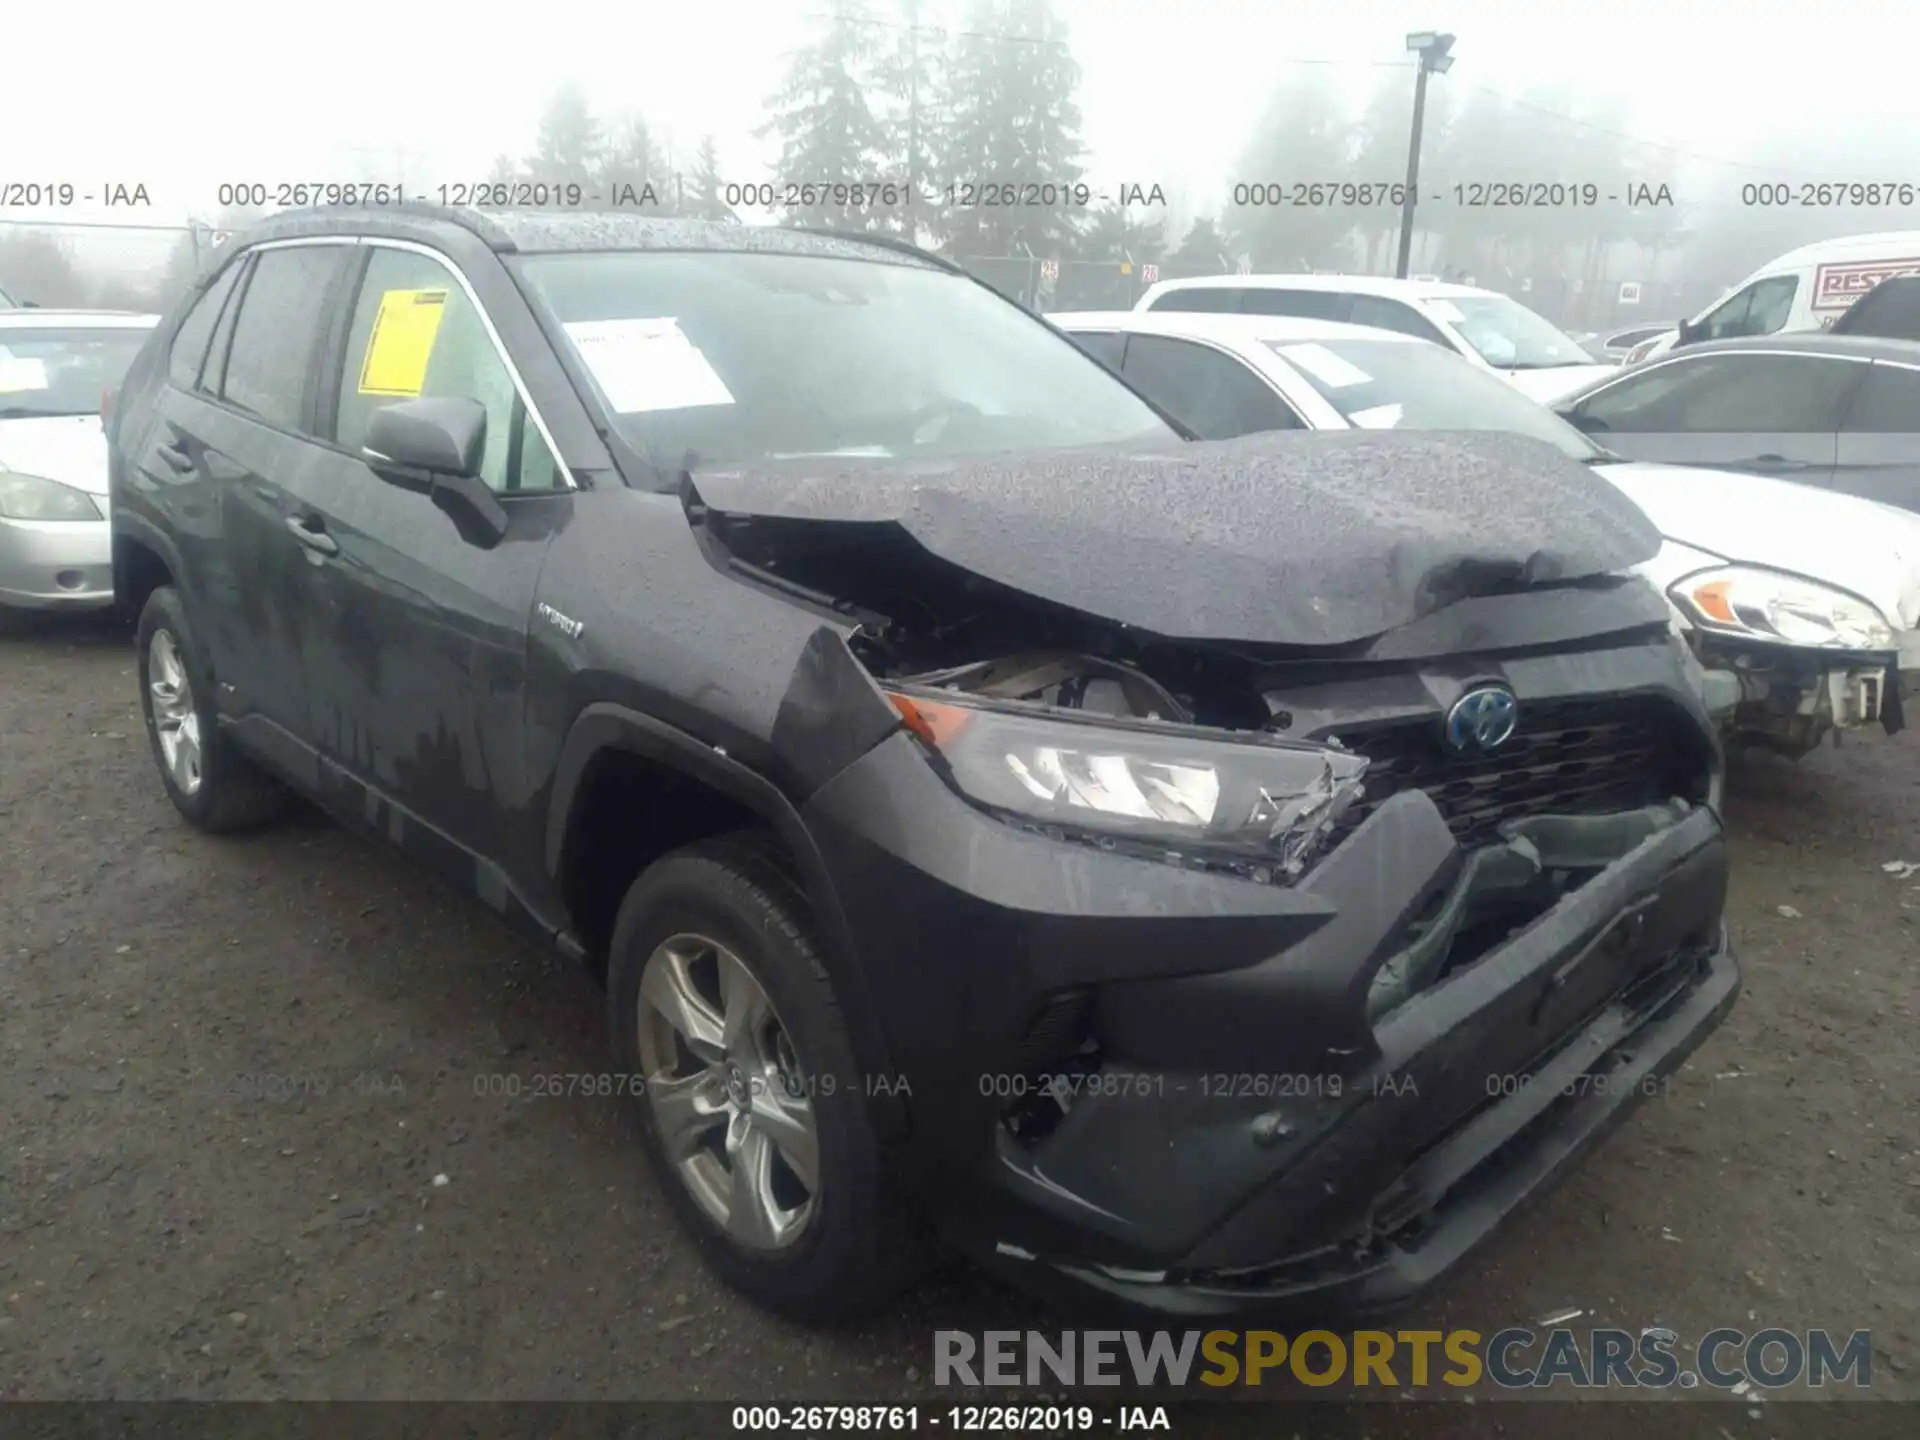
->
134, 586, 288, 835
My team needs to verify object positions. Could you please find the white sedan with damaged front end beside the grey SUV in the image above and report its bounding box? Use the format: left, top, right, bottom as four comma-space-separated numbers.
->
1048, 311, 1920, 758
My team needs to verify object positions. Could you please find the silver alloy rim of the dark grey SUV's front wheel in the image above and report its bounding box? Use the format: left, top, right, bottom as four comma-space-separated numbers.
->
639, 933, 820, 1250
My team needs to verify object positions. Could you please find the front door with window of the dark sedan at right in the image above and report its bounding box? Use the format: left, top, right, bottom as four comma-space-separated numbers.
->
1565, 349, 1866, 486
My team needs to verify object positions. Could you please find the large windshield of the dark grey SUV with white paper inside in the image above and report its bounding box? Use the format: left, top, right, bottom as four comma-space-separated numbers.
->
522, 252, 1169, 465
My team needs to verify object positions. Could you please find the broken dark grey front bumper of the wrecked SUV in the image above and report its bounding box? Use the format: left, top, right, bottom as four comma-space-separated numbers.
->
804, 652, 1738, 1315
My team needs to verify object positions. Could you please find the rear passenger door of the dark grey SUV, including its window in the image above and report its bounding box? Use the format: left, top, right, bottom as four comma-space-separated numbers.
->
136, 240, 351, 785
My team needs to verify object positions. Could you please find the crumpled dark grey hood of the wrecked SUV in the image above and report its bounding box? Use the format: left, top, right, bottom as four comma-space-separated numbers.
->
695, 430, 1659, 645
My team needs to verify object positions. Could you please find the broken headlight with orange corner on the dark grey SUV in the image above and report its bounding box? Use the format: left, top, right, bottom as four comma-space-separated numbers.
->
891, 691, 1367, 879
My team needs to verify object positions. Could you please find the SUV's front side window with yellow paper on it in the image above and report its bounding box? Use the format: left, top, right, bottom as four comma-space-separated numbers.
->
334, 248, 561, 492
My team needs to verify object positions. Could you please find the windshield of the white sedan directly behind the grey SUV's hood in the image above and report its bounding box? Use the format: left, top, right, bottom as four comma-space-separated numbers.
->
1267, 340, 1607, 461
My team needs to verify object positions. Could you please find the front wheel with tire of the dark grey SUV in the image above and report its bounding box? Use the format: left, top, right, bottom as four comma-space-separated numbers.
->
607, 837, 922, 1321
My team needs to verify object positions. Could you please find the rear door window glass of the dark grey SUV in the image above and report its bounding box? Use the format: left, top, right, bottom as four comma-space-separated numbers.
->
221, 246, 351, 430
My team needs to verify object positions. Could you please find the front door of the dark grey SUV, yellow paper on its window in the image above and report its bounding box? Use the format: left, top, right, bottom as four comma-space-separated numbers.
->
295, 240, 572, 887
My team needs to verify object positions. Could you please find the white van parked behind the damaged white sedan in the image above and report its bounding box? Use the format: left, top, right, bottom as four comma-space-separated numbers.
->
1135, 275, 1617, 403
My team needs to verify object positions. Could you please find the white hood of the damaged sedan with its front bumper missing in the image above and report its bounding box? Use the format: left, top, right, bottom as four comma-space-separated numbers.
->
1594, 461, 1920, 630
